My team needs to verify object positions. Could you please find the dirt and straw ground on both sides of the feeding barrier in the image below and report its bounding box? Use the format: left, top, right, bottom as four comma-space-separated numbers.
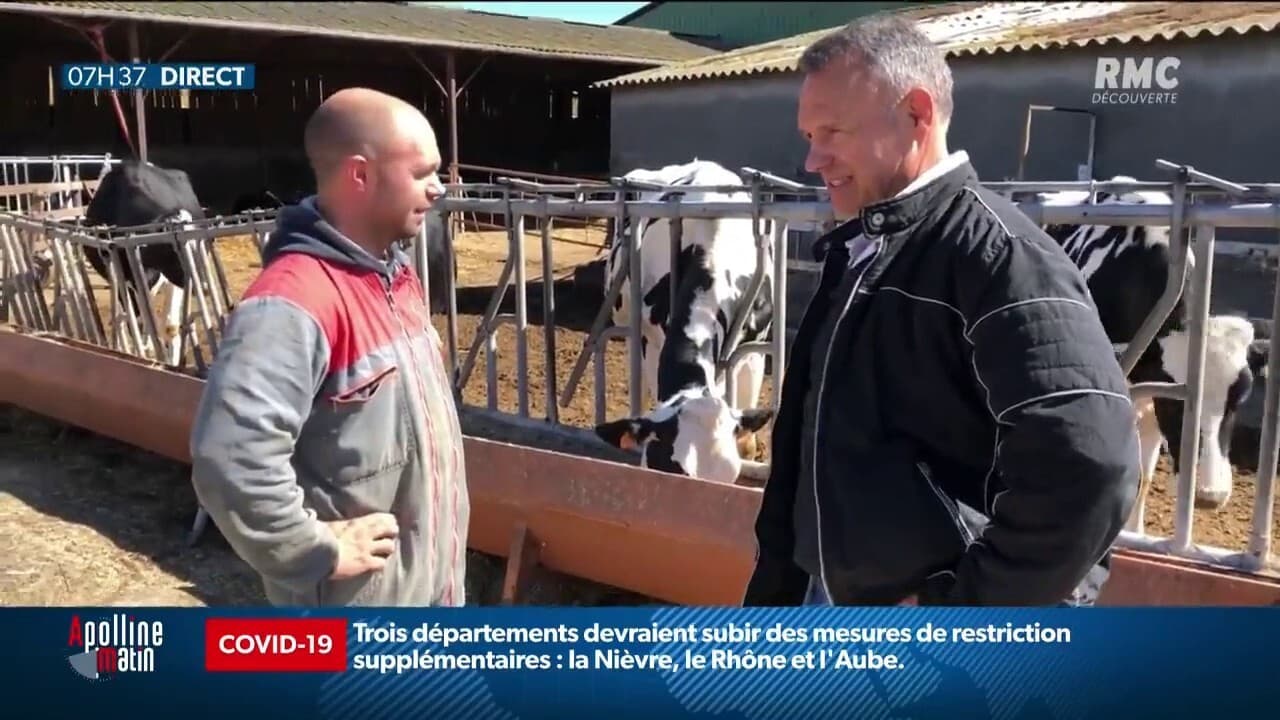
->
0, 220, 1280, 605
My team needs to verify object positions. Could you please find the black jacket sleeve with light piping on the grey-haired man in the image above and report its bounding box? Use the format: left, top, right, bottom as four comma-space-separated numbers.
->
937, 228, 1140, 606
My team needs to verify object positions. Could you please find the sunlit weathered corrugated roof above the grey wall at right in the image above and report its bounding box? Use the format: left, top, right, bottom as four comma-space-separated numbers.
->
595, 3, 1280, 87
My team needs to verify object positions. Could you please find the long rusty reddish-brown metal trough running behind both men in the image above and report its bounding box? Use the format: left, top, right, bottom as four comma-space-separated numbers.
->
0, 325, 1280, 605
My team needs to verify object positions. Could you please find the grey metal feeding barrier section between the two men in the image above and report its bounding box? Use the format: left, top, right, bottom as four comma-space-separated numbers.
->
438, 168, 808, 423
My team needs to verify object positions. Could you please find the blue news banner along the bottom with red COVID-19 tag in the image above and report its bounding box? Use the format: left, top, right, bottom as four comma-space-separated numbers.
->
0, 607, 1280, 720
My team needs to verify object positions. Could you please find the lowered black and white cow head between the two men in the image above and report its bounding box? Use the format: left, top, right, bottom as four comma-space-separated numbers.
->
595, 388, 773, 484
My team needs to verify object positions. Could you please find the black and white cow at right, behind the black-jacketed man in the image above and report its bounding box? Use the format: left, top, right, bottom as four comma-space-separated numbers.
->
1039, 176, 1270, 515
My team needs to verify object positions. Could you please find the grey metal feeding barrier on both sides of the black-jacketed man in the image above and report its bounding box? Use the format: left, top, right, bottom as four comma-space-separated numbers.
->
427, 160, 1280, 570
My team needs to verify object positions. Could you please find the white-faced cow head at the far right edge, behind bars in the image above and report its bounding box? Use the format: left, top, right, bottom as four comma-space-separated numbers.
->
1155, 315, 1271, 509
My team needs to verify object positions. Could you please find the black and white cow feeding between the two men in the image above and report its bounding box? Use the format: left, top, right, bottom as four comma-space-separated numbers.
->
595, 159, 773, 483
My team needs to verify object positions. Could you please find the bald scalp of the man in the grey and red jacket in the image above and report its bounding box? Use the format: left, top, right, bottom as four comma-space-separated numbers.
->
302, 87, 435, 183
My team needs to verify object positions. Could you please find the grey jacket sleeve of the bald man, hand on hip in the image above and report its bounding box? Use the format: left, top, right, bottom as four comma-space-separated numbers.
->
191, 297, 338, 593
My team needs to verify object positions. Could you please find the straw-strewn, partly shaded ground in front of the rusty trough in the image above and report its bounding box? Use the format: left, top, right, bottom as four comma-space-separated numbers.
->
0, 405, 653, 606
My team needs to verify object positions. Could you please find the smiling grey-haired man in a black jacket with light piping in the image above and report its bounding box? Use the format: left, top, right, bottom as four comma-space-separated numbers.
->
744, 15, 1139, 606
